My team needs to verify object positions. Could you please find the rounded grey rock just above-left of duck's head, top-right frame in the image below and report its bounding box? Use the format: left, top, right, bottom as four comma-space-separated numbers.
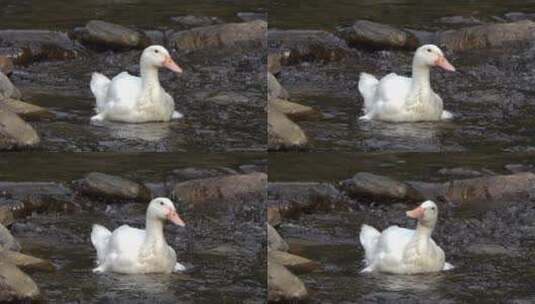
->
339, 20, 419, 50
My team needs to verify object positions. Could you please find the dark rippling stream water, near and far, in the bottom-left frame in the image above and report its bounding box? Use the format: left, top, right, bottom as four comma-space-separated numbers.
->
0, 153, 266, 303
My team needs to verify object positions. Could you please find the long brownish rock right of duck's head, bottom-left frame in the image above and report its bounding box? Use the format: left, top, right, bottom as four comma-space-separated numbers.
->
173, 172, 267, 207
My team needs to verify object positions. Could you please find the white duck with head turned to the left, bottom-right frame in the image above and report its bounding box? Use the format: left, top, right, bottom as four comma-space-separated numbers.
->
360, 201, 453, 274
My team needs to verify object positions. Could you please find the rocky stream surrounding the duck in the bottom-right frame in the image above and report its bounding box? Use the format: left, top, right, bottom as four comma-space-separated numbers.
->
267, 153, 535, 303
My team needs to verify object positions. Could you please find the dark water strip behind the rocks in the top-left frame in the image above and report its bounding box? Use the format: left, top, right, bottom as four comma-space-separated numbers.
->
0, 0, 266, 30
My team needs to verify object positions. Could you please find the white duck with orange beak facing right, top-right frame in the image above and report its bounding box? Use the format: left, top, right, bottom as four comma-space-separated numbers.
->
359, 44, 455, 122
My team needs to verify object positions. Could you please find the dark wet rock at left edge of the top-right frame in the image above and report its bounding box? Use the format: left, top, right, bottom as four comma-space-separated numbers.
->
268, 30, 350, 64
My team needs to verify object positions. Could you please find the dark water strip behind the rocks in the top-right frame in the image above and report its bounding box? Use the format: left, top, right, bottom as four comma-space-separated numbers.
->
269, 0, 535, 29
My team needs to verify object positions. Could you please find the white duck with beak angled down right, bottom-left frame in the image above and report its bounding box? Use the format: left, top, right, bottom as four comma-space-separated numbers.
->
91, 197, 186, 273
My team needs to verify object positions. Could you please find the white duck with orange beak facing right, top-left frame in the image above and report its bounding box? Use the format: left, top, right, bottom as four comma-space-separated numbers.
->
90, 45, 183, 123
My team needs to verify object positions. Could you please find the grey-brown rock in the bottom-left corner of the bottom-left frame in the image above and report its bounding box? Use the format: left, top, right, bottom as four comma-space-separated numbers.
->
0, 260, 39, 303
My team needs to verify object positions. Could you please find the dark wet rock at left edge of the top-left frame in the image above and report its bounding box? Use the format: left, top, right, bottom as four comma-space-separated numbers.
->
0, 30, 78, 63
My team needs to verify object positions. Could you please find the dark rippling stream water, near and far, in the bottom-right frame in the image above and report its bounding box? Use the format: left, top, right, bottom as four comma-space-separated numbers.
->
269, 152, 535, 303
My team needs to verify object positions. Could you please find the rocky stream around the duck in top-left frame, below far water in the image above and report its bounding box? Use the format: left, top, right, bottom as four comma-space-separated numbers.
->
0, 14, 267, 152
